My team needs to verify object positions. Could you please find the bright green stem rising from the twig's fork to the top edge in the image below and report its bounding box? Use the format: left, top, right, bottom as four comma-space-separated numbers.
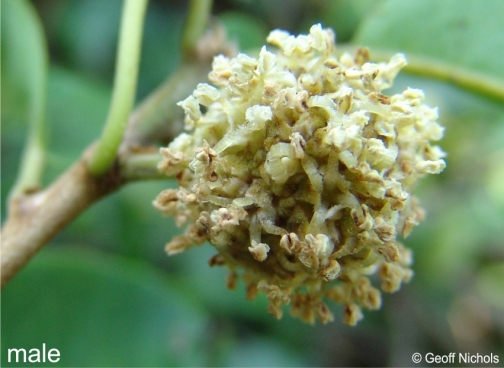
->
88, 0, 148, 176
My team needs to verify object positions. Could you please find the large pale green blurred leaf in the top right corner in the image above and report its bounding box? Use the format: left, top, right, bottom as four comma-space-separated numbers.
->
353, 0, 504, 79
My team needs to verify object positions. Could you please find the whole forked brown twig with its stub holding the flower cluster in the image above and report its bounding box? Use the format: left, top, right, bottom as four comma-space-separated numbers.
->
1, 0, 223, 288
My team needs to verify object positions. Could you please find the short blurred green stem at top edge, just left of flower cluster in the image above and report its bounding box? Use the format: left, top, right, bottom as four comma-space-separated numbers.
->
181, 0, 212, 61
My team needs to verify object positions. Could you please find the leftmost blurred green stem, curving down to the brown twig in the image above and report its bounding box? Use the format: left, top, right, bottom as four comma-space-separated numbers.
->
6, 1, 48, 199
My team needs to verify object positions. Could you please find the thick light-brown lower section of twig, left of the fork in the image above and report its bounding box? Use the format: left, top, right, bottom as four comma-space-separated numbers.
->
1, 148, 122, 288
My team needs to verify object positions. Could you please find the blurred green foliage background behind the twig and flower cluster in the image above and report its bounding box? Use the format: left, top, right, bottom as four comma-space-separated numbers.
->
1, 0, 504, 367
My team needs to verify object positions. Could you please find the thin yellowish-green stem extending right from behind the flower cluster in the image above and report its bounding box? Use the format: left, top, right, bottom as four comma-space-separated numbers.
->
338, 45, 504, 102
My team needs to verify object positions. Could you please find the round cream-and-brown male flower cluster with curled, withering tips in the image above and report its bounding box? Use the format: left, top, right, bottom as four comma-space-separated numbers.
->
154, 25, 445, 325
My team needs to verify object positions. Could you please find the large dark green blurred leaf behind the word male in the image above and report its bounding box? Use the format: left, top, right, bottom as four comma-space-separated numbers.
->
2, 248, 207, 367
